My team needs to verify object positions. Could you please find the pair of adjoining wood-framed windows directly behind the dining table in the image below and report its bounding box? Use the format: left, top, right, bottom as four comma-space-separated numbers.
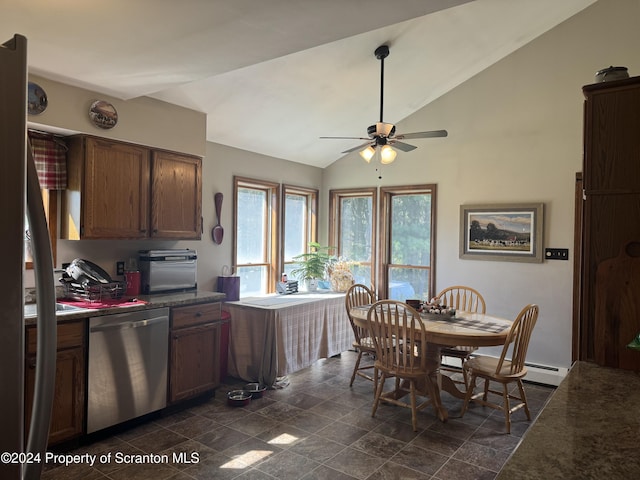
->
329, 185, 436, 301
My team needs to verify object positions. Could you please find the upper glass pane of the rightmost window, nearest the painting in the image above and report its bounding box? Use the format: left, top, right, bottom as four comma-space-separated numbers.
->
390, 194, 431, 267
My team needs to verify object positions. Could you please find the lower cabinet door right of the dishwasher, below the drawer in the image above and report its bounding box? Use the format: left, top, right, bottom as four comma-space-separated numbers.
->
169, 322, 221, 403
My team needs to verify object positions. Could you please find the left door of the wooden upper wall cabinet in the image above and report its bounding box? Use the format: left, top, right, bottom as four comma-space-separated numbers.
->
81, 138, 149, 238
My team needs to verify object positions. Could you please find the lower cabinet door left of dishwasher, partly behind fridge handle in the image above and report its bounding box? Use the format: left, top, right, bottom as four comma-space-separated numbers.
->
25, 347, 84, 445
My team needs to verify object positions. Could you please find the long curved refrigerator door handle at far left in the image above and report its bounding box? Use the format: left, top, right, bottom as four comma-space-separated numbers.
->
23, 140, 57, 480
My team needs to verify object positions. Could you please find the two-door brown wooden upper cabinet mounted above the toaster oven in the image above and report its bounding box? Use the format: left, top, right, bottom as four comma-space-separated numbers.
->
60, 135, 202, 240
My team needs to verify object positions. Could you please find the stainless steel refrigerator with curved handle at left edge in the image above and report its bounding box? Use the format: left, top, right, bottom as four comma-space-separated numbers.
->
0, 35, 56, 480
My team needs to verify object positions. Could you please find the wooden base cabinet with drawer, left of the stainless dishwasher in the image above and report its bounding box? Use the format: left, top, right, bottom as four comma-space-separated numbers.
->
25, 320, 85, 445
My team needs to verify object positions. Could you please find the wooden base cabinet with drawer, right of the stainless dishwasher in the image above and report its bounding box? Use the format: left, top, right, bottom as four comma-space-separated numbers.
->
168, 302, 222, 403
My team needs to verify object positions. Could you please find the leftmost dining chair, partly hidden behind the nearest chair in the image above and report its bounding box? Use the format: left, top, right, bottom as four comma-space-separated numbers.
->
344, 283, 377, 391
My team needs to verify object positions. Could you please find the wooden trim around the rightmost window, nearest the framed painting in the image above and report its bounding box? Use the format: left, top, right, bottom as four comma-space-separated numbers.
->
377, 183, 437, 298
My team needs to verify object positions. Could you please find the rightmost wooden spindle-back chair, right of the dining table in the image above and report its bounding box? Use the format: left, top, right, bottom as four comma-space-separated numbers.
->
460, 304, 538, 433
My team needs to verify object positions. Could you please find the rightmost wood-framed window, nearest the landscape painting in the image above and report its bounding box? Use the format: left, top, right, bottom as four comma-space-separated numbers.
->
381, 185, 436, 301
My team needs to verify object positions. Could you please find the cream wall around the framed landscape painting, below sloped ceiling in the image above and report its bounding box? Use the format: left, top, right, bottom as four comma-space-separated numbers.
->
324, 0, 640, 367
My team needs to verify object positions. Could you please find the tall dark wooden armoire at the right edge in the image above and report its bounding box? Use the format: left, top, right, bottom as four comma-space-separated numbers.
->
578, 77, 640, 371
